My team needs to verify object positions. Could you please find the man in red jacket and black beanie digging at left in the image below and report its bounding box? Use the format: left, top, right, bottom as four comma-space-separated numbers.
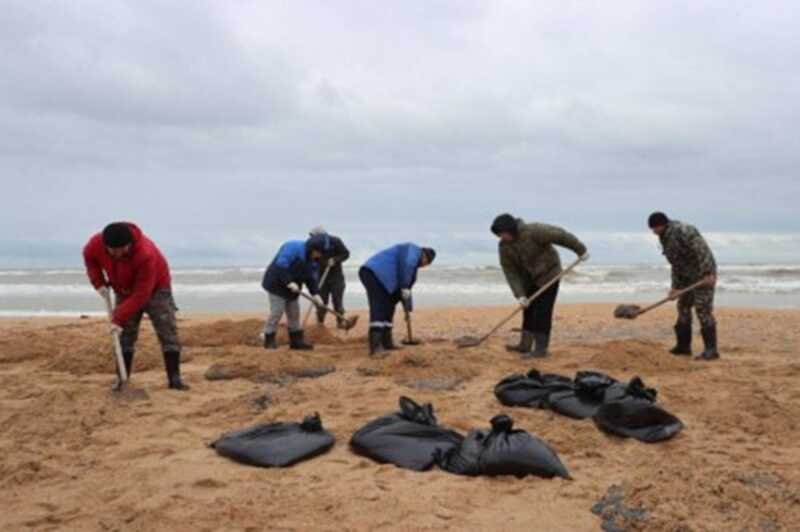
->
83, 222, 189, 390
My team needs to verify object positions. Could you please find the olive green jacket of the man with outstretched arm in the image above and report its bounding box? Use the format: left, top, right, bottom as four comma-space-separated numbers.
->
499, 219, 586, 298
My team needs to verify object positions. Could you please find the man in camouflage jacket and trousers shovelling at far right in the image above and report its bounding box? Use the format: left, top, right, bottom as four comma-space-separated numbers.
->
648, 212, 719, 360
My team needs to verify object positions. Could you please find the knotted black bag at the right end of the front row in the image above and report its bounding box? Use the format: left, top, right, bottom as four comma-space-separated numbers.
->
437, 415, 570, 478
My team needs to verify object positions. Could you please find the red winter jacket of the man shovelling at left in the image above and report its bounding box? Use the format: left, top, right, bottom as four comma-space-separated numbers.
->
83, 222, 171, 327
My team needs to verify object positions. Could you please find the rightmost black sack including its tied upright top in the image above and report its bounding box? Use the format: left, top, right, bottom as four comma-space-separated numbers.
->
592, 377, 684, 443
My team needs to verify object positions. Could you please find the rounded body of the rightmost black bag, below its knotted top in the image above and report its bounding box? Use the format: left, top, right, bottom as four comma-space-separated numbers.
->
592, 397, 683, 443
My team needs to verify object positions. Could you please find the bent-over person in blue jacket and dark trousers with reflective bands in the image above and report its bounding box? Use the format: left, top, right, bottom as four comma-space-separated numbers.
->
358, 242, 436, 356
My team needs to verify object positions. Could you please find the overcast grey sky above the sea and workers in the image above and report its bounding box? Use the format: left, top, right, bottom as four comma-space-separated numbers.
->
0, 0, 800, 266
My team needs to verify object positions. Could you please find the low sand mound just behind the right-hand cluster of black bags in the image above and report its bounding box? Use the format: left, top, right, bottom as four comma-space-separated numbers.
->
589, 340, 691, 376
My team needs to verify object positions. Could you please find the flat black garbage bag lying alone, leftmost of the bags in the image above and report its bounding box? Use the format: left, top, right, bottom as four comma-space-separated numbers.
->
211, 414, 336, 467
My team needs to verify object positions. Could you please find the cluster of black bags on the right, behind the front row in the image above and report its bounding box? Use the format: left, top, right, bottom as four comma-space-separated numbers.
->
494, 370, 683, 443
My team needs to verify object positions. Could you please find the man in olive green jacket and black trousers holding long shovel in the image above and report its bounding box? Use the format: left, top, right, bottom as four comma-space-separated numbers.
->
491, 214, 589, 358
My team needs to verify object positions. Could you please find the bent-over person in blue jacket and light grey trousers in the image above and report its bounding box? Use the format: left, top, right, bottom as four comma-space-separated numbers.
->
261, 236, 325, 350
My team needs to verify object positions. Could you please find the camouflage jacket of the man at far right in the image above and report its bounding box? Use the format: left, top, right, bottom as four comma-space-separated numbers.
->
659, 220, 717, 288
